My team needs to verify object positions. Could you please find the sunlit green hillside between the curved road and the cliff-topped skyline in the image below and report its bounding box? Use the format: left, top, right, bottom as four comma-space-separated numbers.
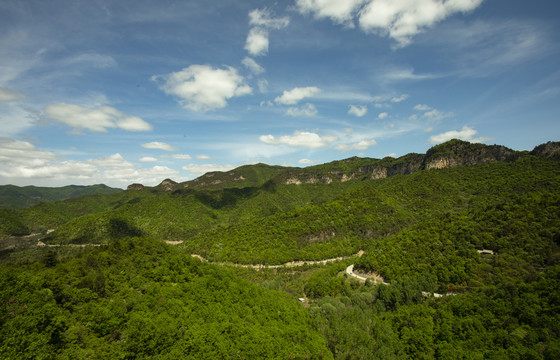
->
22, 140, 557, 255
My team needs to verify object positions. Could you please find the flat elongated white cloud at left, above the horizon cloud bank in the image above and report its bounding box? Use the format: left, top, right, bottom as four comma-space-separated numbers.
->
45, 103, 152, 132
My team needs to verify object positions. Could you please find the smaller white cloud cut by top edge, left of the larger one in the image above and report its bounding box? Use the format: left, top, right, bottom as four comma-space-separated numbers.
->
296, 0, 367, 26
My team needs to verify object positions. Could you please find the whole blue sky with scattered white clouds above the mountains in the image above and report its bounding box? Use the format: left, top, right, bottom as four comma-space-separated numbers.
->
0, 0, 560, 188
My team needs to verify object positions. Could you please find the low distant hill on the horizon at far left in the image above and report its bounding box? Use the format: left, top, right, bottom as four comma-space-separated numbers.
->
0, 184, 123, 209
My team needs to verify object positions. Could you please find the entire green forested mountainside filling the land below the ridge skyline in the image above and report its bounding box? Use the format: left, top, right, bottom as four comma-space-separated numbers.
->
0, 140, 560, 359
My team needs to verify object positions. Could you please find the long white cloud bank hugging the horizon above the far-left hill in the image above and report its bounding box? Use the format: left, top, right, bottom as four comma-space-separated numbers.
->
0, 138, 180, 186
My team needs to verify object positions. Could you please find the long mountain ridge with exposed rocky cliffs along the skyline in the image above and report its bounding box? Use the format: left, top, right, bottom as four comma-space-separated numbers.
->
138, 139, 560, 192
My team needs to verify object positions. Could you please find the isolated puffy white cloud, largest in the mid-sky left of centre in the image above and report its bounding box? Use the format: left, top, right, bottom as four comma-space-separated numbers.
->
152, 65, 252, 112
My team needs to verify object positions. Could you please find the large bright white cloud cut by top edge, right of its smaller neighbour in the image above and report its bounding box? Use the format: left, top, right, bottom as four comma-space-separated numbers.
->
359, 0, 482, 47
